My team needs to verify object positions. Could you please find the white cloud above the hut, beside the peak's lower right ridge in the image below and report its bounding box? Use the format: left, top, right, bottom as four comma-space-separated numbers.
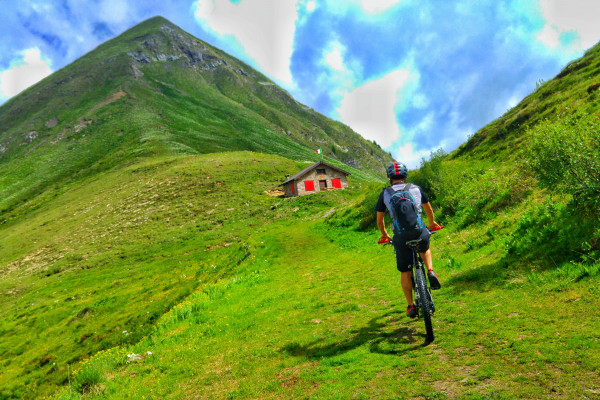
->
338, 69, 411, 147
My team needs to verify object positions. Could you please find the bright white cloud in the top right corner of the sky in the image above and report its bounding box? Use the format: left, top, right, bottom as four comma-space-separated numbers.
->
538, 0, 600, 49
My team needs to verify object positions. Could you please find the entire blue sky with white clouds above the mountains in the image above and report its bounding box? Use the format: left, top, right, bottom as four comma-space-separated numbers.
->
0, 0, 600, 167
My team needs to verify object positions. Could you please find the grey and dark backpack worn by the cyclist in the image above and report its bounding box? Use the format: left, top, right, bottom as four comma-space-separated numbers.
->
386, 183, 424, 240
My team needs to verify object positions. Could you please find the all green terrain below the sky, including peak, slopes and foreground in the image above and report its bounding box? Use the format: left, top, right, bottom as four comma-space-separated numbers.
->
0, 14, 600, 399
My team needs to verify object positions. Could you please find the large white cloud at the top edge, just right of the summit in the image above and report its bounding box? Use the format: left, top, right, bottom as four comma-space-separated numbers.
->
195, 0, 298, 86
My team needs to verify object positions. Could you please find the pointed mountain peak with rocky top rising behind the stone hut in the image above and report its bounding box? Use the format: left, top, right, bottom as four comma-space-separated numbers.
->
0, 17, 391, 219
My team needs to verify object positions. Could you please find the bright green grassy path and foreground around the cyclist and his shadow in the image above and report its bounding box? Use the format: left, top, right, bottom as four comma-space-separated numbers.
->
48, 212, 600, 399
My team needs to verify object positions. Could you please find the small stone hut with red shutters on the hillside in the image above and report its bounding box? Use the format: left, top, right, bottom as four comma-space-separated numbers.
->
279, 161, 350, 197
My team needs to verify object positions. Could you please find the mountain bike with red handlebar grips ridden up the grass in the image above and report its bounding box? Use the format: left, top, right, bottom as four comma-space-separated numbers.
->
381, 227, 442, 342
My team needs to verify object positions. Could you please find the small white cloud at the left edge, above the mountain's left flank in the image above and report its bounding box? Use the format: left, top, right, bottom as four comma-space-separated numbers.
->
0, 47, 52, 98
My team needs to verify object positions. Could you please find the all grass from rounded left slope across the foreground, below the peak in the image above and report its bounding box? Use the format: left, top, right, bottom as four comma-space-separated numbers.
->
0, 152, 600, 399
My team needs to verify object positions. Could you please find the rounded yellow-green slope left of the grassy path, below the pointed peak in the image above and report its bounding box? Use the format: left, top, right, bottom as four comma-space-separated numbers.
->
0, 152, 352, 398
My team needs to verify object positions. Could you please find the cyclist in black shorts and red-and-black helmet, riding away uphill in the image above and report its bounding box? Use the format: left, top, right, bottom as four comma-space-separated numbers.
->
375, 162, 441, 318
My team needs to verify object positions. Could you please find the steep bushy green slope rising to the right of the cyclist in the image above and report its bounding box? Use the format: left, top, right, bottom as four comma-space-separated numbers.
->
411, 37, 600, 269
